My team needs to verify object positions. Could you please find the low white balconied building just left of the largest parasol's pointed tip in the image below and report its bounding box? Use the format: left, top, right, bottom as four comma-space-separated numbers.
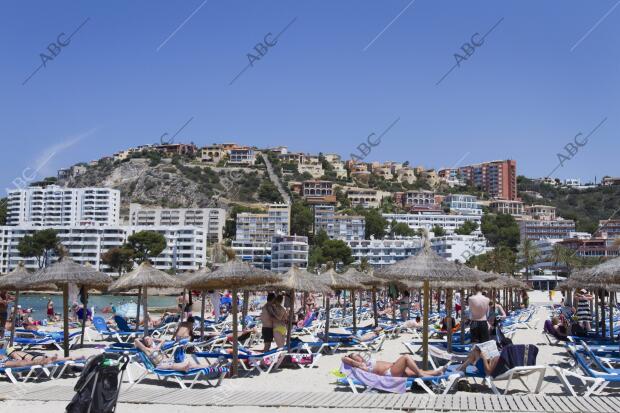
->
347, 237, 422, 267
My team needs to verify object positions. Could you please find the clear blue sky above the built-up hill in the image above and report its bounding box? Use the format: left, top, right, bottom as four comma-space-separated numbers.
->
0, 0, 620, 193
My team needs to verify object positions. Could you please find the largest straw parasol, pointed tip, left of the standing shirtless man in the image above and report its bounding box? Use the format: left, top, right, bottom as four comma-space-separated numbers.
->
376, 236, 497, 368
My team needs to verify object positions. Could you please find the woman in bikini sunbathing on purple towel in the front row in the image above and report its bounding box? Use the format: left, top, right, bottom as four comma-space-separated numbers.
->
342, 353, 445, 377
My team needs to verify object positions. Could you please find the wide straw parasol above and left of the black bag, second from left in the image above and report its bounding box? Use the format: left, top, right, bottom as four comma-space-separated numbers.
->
24, 256, 112, 357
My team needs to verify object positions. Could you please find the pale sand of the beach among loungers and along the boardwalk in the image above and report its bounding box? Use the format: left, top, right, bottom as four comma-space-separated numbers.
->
0, 292, 619, 413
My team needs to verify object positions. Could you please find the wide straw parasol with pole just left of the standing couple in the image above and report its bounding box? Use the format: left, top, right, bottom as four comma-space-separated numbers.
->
184, 259, 278, 375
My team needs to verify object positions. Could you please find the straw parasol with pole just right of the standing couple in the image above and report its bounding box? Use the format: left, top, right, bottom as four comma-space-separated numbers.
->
264, 266, 332, 350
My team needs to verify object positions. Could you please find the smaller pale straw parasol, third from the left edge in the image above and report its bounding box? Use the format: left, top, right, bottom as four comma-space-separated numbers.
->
108, 261, 183, 337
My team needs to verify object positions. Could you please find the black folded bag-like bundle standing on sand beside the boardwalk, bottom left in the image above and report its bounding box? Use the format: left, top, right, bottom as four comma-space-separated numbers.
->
66, 354, 129, 413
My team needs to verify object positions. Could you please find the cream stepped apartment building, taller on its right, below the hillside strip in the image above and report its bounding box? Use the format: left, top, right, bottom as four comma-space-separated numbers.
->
235, 204, 291, 243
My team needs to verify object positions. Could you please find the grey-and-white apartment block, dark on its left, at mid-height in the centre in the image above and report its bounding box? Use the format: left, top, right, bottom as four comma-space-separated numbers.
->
314, 205, 366, 241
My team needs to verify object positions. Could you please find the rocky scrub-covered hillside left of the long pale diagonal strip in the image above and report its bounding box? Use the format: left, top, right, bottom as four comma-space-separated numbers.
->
58, 158, 269, 212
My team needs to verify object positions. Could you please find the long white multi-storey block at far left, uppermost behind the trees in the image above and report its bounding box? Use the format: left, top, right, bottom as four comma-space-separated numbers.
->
6, 185, 121, 226
